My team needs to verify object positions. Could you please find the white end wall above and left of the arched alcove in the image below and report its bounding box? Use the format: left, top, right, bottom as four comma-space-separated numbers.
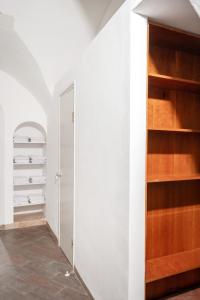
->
0, 71, 47, 224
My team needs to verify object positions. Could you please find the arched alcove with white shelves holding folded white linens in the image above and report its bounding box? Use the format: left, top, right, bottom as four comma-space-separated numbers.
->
13, 121, 46, 224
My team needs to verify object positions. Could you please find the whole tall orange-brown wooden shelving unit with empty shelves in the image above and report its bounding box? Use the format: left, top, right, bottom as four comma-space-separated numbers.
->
146, 24, 200, 299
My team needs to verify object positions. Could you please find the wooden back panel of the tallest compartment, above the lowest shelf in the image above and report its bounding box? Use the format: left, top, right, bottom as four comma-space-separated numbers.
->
146, 180, 200, 260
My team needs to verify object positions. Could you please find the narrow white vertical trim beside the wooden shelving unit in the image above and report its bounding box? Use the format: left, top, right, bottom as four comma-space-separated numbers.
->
128, 12, 148, 300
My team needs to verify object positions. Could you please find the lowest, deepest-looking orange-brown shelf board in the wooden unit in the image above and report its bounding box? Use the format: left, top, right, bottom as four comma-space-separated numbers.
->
146, 248, 200, 283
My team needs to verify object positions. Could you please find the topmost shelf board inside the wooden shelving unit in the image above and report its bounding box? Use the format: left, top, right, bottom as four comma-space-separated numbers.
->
149, 73, 200, 93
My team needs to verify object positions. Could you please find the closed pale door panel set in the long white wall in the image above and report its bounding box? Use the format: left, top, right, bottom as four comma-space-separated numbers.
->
60, 86, 74, 265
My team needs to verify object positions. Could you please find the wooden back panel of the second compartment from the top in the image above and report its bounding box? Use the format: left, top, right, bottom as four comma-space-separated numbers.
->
148, 87, 200, 130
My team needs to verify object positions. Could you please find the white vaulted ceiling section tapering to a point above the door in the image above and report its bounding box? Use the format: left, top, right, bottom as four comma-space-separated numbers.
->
0, 0, 116, 90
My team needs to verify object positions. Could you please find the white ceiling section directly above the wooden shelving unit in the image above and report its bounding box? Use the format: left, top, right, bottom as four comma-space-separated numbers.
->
134, 0, 200, 34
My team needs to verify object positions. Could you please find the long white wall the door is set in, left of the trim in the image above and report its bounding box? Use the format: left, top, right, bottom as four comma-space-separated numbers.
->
51, 1, 130, 300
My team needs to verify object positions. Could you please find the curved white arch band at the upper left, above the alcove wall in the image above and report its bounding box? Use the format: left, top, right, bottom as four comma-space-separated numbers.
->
0, 15, 52, 112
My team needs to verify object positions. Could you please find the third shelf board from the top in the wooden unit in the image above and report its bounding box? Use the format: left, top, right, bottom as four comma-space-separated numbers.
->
147, 174, 200, 183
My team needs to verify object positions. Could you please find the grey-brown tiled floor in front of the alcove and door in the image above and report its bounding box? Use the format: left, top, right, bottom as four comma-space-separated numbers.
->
0, 226, 91, 300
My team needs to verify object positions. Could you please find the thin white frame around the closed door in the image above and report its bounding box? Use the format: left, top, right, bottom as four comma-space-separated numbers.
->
58, 81, 76, 268
